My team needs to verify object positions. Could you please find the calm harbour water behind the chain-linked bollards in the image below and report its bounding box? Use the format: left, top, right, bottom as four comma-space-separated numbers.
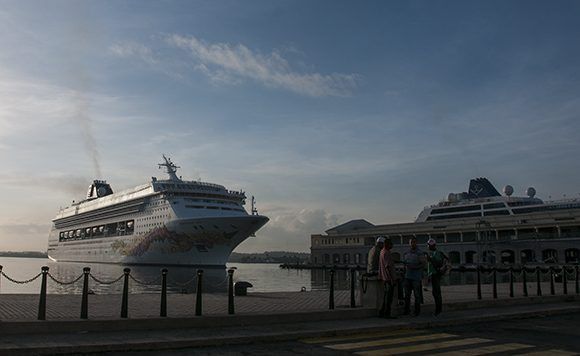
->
0, 257, 358, 294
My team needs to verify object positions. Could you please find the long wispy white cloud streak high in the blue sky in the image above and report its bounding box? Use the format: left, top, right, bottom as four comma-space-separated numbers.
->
109, 34, 360, 97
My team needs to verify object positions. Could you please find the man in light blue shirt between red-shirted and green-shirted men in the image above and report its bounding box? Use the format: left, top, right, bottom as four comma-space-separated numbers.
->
403, 236, 425, 316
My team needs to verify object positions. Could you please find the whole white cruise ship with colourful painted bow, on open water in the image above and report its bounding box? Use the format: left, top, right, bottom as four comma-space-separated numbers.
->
48, 156, 268, 267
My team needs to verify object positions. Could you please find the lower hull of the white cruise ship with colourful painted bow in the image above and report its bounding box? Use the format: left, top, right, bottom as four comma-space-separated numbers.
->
49, 215, 268, 267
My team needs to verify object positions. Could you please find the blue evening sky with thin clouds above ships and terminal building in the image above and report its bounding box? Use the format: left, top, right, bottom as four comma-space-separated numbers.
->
0, 0, 580, 252
